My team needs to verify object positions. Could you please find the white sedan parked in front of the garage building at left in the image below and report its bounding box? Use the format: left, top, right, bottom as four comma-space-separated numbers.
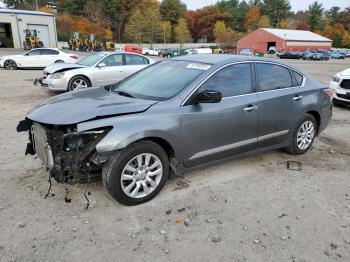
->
0, 48, 78, 70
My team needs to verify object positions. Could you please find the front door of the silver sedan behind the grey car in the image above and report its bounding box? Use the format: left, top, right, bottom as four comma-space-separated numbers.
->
93, 54, 125, 85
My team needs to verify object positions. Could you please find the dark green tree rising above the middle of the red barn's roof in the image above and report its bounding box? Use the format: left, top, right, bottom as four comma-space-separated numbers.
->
261, 0, 291, 27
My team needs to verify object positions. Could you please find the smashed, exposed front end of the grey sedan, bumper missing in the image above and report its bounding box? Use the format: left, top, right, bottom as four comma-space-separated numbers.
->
17, 118, 111, 184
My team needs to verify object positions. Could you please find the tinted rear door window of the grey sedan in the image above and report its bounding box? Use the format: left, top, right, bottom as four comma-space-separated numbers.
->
256, 63, 293, 91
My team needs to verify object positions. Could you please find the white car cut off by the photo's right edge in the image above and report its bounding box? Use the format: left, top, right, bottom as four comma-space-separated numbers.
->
329, 68, 350, 106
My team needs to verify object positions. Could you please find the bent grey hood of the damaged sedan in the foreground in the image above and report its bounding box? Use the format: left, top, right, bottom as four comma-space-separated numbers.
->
27, 87, 157, 125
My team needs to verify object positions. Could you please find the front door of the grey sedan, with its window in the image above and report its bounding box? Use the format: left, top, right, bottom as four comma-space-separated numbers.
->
181, 63, 259, 167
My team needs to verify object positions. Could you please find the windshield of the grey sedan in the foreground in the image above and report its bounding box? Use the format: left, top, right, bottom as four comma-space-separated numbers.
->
111, 60, 210, 101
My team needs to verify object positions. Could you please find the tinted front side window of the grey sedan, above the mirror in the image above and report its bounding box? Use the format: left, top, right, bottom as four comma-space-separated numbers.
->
199, 64, 252, 97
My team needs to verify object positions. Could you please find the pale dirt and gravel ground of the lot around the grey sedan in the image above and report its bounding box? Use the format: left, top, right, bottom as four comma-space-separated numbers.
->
0, 51, 350, 262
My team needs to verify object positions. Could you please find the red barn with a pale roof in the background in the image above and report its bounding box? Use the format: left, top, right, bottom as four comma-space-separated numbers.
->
237, 28, 332, 53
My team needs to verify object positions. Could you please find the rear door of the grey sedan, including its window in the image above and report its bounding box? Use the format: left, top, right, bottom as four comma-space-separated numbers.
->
255, 62, 305, 147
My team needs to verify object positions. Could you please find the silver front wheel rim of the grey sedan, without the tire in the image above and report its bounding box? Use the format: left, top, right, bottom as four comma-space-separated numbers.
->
120, 153, 163, 198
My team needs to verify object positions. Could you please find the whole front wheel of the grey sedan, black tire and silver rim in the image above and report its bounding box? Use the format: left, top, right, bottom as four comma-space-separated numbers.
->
102, 141, 170, 206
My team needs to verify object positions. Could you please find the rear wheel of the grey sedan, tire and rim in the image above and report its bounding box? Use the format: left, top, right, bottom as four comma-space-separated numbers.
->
286, 114, 317, 155
